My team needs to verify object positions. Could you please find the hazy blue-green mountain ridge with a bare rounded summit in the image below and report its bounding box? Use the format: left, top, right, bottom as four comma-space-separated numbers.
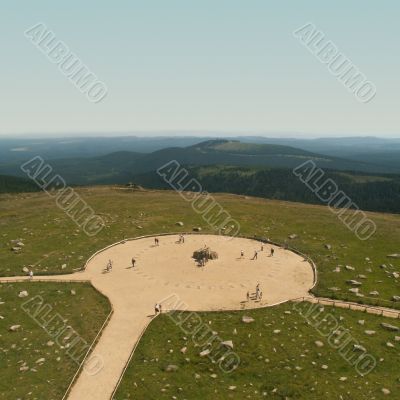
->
0, 139, 391, 184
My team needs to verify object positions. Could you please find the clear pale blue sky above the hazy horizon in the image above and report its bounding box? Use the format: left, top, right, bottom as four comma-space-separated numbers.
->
0, 0, 400, 137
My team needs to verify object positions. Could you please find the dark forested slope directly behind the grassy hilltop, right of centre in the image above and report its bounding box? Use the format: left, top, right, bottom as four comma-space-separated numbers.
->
134, 166, 400, 213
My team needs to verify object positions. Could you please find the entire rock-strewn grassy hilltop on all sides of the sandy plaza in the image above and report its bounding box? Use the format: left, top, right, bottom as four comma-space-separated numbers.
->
0, 187, 400, 400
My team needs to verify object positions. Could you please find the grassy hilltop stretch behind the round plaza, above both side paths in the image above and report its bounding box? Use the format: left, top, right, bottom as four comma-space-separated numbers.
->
0, 187, 400, 307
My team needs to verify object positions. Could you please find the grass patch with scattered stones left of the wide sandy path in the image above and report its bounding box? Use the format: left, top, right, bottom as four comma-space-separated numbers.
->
0, 282, 110, 400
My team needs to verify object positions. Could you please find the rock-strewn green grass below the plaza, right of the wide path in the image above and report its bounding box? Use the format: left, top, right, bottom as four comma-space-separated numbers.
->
115, 303, 400, 400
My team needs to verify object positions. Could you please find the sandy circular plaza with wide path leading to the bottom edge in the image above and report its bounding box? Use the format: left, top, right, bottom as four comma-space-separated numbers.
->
0, 234, 314, 400
